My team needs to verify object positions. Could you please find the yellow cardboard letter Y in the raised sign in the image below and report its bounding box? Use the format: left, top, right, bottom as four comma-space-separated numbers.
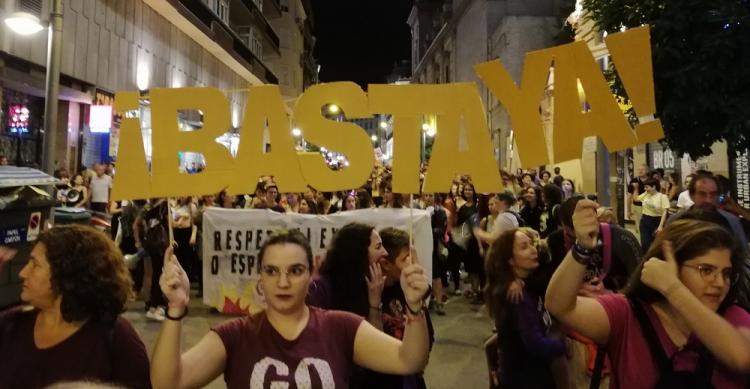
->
474, 49, 554, 167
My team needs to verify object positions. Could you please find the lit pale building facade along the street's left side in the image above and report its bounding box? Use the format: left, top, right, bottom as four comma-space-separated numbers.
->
0, 0, 311, 171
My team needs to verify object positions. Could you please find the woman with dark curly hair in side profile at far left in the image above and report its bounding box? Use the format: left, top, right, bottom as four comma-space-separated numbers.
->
0, 225, 151, 388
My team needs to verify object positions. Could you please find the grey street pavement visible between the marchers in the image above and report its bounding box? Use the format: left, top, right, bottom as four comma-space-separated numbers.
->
124, 290, 492, 389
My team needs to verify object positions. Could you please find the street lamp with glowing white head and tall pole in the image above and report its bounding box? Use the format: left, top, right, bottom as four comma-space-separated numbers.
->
5, 0, 63, 175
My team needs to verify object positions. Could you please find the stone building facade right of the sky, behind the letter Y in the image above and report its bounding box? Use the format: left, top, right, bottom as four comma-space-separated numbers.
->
408, 0, 574, 177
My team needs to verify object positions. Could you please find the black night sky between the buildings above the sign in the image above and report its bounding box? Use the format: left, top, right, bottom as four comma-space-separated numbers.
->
312, 0, 413, 88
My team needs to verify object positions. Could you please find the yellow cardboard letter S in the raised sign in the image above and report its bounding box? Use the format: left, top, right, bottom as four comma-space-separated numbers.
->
294, 82, 375, 191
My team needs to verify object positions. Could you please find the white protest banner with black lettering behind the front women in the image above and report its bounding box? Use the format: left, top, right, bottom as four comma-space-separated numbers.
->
203, 207, 432, 314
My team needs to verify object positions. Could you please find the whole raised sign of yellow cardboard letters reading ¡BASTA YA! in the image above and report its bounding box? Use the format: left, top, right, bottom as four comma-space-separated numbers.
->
112, 27, 664, 199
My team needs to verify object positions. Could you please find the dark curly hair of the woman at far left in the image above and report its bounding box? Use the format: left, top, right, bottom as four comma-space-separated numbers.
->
37, 225, 133, 322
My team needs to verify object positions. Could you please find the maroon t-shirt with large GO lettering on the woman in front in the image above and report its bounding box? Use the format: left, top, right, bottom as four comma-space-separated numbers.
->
213, 307, 362, 389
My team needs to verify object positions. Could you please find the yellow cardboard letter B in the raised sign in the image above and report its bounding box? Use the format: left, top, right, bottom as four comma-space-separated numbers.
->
150, 88, 234, 197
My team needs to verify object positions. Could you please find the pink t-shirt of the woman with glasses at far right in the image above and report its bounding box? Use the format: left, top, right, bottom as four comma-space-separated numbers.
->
598, 293, 750, 389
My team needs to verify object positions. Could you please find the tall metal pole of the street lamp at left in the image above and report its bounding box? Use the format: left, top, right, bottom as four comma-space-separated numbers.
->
43, 0, 63, 174
